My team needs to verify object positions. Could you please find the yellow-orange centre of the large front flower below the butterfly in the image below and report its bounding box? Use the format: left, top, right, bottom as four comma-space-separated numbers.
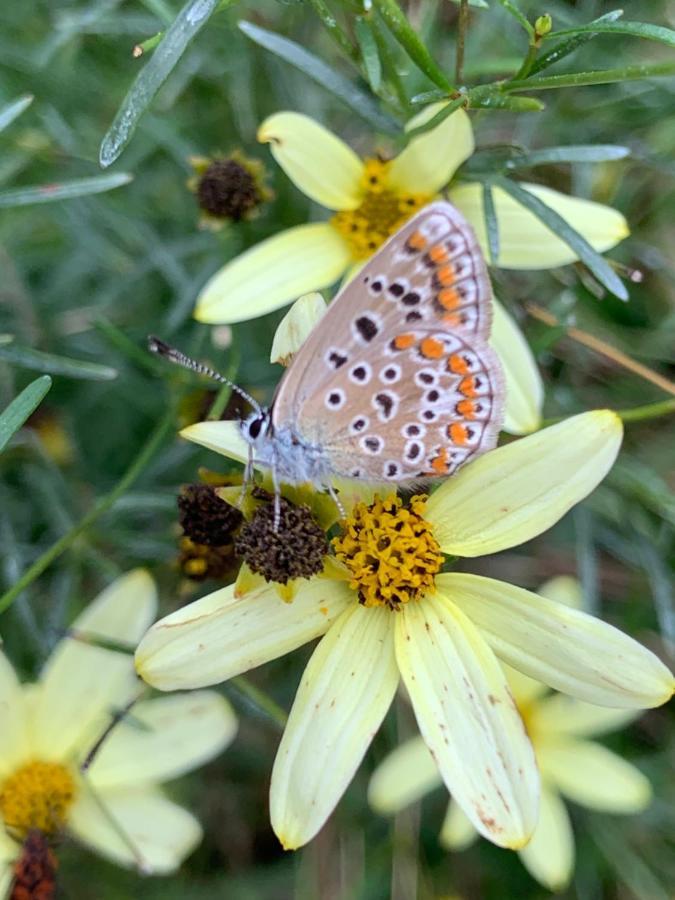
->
333, 495, 443, 609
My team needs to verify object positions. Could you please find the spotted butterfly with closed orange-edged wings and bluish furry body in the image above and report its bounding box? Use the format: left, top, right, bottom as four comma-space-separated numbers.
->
242, 202, 504, 486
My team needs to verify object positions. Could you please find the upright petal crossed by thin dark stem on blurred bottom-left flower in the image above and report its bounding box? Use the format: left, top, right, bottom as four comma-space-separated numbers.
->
33, 569, 157, 759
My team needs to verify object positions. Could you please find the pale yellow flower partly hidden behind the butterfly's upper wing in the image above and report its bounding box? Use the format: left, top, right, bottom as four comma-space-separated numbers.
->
195, 104, 628, 323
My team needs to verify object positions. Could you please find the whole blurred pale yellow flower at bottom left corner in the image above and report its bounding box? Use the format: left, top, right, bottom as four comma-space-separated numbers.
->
0, 569, 237, 884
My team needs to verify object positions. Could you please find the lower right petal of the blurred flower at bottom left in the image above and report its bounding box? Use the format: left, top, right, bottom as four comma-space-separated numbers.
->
68, 787, 202, 874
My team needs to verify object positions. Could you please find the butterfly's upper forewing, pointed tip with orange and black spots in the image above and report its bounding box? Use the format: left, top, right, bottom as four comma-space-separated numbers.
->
272, 201, 492, 428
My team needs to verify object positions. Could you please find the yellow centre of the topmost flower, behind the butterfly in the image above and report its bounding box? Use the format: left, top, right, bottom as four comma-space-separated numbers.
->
331, 159, 432, 259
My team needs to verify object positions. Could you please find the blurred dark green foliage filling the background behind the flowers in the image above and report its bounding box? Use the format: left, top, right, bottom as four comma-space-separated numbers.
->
0, 0, 675, 900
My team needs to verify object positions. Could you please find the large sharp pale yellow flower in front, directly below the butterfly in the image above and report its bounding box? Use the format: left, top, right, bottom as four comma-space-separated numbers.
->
136, 411, 673, 849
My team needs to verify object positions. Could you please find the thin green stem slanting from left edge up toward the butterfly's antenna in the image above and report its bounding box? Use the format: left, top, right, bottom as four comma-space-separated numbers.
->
0, 407, 174, 613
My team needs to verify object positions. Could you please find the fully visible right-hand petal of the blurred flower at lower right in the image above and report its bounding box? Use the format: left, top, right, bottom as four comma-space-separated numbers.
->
537, 740, 652, 814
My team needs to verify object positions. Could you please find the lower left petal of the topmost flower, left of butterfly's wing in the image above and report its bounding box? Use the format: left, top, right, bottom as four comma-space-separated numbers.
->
195, 222, 351, 324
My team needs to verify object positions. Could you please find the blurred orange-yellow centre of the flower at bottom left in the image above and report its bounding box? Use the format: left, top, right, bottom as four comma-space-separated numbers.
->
0, 760, 75, 837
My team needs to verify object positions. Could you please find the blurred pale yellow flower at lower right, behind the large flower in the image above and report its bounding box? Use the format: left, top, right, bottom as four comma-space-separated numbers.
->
368, 576, 652, 891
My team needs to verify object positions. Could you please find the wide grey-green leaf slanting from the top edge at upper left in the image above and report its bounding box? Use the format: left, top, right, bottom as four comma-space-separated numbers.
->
99, 0, 219, 169
